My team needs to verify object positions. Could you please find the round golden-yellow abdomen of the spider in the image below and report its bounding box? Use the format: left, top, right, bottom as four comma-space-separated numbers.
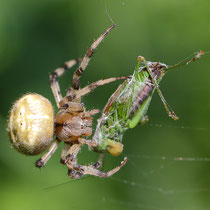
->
7, 93, 54, 155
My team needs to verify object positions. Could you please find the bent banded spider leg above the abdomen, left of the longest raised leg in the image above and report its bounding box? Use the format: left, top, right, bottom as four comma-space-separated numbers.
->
50, 60, 78, 107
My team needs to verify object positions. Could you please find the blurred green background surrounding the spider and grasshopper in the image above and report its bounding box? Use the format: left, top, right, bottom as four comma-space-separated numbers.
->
0, 0, 210, 210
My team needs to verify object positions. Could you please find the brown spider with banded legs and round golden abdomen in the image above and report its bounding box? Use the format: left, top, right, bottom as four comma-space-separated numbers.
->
8, 25, 127, 179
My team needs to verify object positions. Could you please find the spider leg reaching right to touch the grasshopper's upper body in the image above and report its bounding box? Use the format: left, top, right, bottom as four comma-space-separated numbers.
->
75, 76, 128, 99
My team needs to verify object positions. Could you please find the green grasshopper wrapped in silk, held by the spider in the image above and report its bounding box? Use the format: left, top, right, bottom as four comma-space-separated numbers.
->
93, 51, 204, 156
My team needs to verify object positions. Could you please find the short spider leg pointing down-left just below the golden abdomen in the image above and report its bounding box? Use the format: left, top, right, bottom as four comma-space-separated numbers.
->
35, 139, 60, 168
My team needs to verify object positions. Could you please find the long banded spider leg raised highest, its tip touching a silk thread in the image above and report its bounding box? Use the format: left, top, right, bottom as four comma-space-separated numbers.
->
72, 25, 115, 90
